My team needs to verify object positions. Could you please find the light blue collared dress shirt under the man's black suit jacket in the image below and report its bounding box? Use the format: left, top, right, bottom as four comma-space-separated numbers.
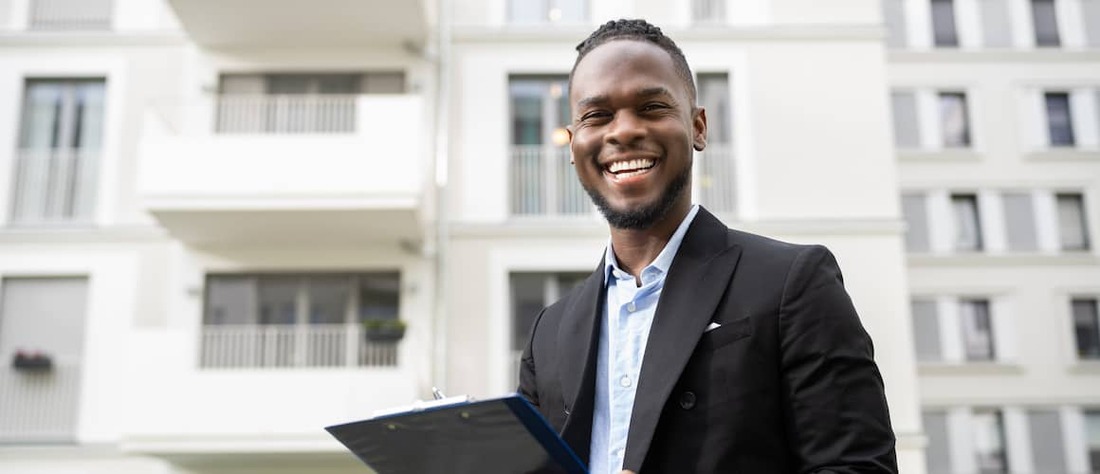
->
589, 206, 699, 474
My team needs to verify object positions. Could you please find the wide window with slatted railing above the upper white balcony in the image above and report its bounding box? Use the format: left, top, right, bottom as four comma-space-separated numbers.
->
217, 73, 405, 134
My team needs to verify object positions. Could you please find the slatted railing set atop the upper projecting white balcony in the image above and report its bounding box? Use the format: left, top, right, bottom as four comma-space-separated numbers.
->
215, 95, 359, 133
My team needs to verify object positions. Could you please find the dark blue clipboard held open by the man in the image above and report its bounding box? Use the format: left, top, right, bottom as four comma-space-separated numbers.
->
325, 395, 587, 474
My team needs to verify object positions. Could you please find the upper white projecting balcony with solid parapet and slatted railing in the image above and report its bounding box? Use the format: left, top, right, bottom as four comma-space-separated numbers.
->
139, 95, 428, 244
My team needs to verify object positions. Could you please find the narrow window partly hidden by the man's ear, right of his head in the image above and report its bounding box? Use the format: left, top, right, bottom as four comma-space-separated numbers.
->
694, 73, 737, 214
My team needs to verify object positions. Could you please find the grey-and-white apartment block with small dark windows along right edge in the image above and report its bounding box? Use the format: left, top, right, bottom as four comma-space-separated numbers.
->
882, 0, 1100, 473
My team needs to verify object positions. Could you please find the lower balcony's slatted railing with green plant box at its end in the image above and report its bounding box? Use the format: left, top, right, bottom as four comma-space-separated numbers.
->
200, 324, 398, 368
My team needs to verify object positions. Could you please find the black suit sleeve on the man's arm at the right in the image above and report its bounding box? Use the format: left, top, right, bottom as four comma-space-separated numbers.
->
779, 246, 898, 474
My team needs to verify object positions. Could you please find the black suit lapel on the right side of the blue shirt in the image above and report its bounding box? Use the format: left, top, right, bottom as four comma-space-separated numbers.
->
624, 209, 740, 471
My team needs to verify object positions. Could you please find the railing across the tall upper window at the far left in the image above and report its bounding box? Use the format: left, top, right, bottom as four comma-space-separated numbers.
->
10, 148, 99, 227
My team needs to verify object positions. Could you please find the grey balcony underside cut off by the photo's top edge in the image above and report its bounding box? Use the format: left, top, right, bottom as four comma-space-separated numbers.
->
169, 0, 429, 47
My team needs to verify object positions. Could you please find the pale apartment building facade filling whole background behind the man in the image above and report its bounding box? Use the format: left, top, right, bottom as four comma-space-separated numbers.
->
0, 0, 1100, 474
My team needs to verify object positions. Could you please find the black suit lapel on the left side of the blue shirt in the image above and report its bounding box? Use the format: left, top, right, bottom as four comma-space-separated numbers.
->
558, 261, 606, 463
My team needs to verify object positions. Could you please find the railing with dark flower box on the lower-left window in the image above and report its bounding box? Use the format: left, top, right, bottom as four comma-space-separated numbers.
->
0, 361, 80, 443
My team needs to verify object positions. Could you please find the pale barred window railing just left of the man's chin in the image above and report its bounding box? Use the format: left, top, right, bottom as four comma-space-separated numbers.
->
512, 145, 592, 216
